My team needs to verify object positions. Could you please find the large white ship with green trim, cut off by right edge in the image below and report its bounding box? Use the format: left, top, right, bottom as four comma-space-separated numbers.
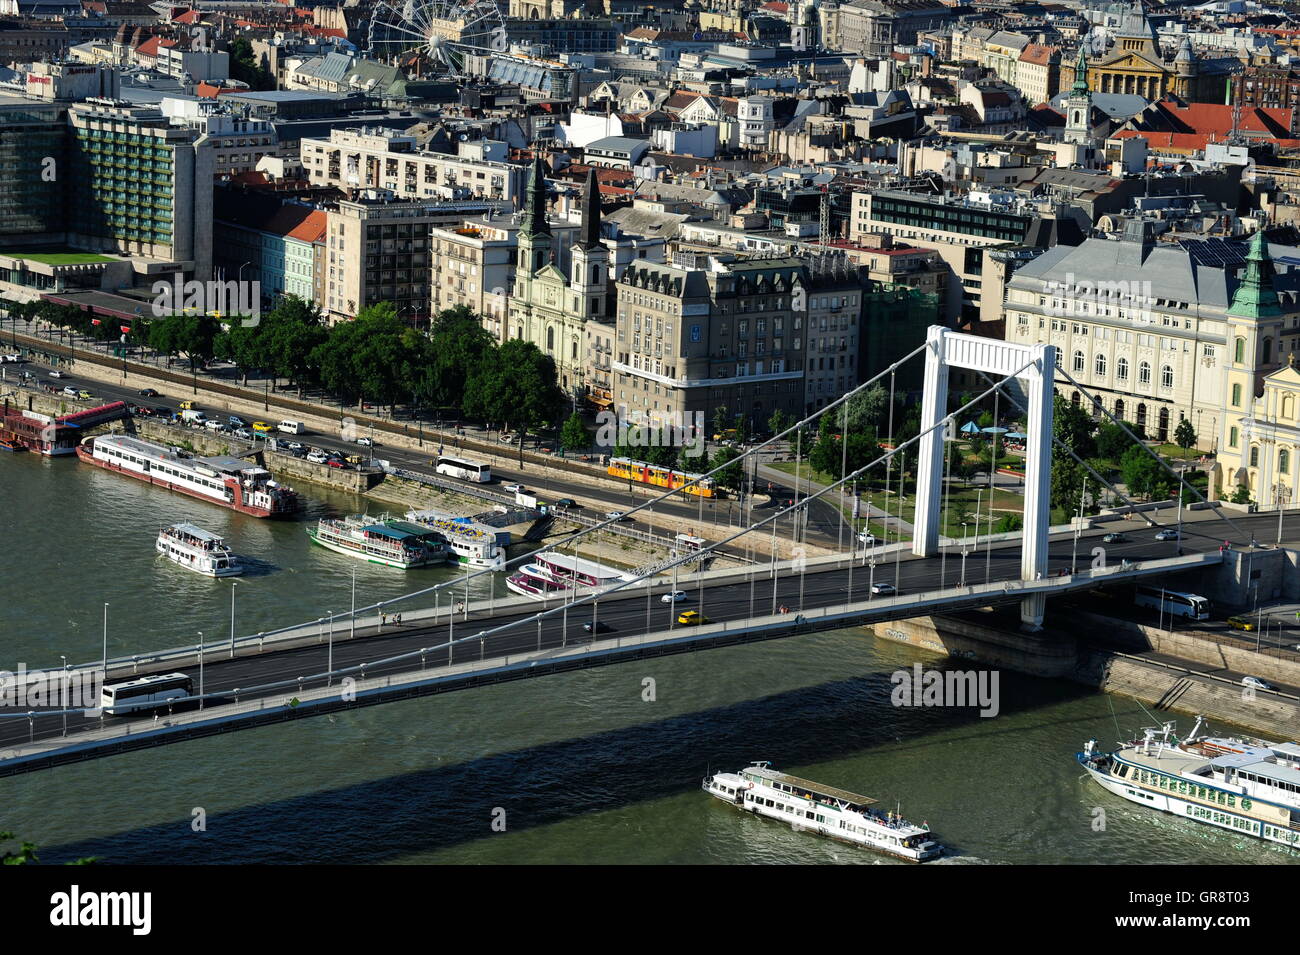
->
1075, 716, 1300, 847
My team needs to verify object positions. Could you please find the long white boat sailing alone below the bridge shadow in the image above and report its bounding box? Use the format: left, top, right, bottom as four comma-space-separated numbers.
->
703, 763, 944, 863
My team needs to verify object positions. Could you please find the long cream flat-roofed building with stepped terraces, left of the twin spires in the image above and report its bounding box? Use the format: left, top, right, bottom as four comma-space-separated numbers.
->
302, 129, 524, 204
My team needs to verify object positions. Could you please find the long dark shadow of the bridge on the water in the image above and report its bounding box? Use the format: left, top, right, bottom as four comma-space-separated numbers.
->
42, 660, 1107, 864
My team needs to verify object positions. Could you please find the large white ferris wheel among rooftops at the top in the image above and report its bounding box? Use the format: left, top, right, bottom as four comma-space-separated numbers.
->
369, 0, 510, 77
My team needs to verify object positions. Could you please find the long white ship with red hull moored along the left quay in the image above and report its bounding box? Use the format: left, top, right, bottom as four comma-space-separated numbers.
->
77, 434, 299, 517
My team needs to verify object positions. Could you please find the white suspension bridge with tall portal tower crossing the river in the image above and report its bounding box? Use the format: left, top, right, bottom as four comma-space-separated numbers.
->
0, 326, 1300, 776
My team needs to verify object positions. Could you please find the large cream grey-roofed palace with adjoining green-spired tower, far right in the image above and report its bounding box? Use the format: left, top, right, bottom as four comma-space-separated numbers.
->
1005, 220, 1300, 452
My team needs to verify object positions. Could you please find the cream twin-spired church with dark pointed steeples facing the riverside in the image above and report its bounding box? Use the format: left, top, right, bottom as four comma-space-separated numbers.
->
508, 157, 611, 396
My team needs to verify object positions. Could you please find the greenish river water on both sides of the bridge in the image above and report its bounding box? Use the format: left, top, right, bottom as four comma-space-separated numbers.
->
0, 455, 1297, 865
